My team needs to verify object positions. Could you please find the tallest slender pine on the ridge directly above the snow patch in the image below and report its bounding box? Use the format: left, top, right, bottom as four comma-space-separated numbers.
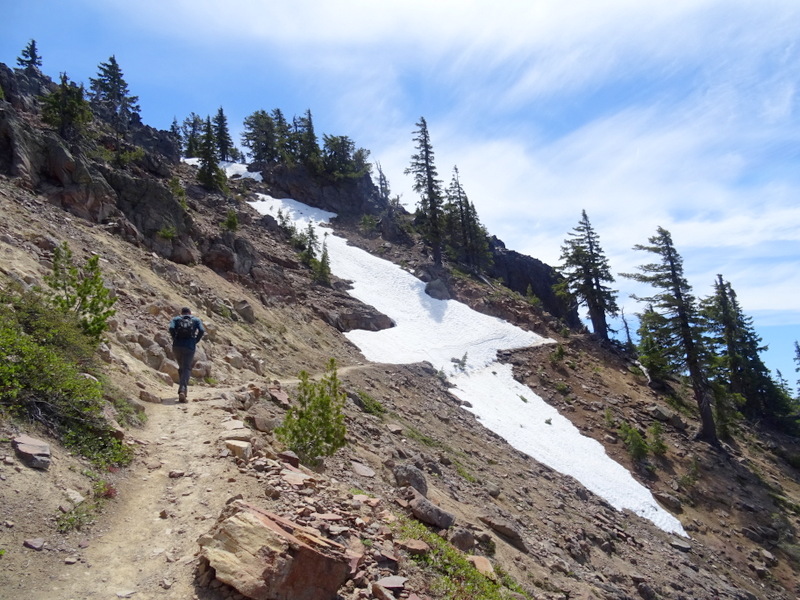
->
405, 117, 443, 265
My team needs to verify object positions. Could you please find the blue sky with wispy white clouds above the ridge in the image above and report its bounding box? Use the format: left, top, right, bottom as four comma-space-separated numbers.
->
0, 0, 800, 392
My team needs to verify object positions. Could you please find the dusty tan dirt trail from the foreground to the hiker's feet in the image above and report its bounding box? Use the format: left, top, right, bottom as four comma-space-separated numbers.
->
26, 390, 249, 600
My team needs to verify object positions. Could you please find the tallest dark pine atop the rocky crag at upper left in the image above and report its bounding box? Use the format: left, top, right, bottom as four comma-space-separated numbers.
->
89, 55, 140, 159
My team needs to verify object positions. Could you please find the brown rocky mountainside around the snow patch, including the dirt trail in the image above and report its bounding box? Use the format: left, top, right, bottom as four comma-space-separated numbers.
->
0, 65, 800, 600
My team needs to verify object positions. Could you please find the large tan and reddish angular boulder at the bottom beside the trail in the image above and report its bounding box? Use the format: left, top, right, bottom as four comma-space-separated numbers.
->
200, 500, 350, 600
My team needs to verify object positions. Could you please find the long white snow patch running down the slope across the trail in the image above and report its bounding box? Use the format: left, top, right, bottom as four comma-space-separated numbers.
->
252, 195, 686, 536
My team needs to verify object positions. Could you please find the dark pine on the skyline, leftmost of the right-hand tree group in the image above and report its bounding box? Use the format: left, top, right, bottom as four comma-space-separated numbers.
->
559, 210, 619, 340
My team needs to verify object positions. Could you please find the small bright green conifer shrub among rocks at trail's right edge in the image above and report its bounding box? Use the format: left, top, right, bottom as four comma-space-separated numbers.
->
275, 359, 347, 464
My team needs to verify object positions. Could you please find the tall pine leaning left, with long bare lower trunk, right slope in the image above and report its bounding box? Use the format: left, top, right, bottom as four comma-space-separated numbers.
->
623, 227, 719, 445
